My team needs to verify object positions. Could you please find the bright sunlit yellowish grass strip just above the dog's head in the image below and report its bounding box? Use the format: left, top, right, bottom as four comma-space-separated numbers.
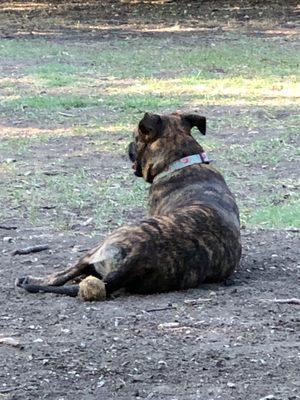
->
107, 75, 300, 105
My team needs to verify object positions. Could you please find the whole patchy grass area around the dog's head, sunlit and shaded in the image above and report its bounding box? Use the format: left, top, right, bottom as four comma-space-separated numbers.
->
0, 34, 300, 229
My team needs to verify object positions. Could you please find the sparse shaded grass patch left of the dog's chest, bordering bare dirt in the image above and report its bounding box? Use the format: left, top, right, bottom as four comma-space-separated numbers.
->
0, 168, 148, 230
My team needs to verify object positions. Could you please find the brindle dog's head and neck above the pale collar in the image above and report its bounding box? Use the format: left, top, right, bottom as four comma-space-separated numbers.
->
128, 113, 206, 183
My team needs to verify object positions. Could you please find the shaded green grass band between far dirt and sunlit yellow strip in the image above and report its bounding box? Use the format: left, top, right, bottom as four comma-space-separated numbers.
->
0, 36, 299, 78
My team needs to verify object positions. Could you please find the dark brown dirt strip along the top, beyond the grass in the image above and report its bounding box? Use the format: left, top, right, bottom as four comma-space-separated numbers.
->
0, 0, 299, 41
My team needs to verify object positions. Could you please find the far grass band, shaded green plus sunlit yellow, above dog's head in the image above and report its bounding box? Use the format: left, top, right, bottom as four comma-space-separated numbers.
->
0, 36, 299, 119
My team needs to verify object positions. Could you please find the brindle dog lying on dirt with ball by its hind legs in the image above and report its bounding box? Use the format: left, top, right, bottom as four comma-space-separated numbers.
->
17, 113, 241, 300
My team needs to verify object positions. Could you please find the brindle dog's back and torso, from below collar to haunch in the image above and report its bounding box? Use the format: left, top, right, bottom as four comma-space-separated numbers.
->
137, 164, 241, 288
